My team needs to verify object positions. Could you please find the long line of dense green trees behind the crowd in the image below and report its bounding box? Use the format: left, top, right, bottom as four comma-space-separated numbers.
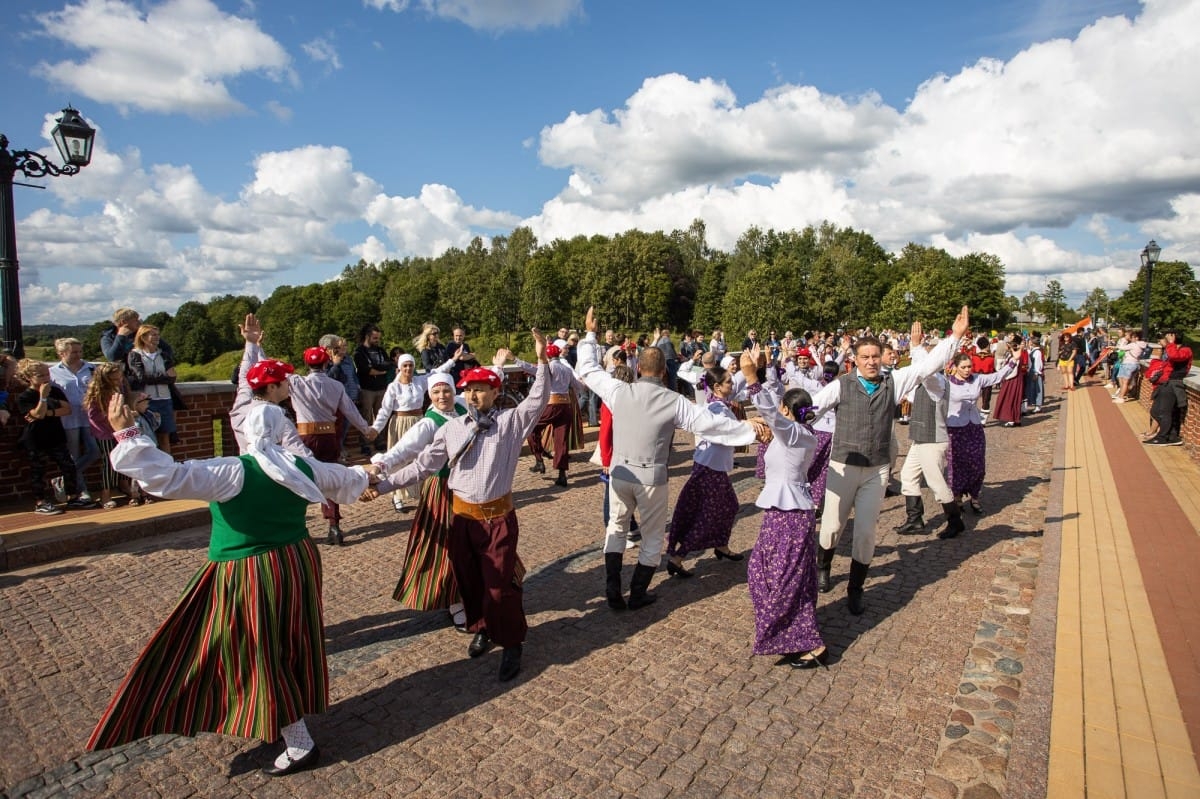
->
32, 220, 1200, 364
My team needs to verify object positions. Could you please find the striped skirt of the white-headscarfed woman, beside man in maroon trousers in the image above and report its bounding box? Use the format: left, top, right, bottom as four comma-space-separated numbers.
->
391, 475, 458, 611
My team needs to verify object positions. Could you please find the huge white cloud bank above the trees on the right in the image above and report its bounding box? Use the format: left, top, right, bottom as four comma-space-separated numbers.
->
527, 0, 1200, 302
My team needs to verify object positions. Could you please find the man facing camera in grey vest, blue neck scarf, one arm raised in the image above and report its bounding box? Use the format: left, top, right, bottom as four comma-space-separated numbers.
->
812, 306, 971, 615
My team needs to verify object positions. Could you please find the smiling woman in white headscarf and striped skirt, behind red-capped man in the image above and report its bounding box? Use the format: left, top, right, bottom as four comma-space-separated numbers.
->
371, 373, 467, 632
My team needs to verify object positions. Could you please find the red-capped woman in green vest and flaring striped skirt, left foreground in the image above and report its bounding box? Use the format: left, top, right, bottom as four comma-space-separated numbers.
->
88, 360, 368, 776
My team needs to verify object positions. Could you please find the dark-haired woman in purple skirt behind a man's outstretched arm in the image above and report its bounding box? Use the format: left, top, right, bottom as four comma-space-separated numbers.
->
667, 367, 744, 577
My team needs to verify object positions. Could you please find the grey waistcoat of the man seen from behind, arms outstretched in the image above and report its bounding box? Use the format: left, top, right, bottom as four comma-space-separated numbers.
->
608, 378, 679, 486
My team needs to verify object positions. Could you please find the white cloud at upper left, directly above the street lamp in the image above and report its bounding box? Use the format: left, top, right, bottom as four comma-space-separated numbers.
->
37, 0, 294, 118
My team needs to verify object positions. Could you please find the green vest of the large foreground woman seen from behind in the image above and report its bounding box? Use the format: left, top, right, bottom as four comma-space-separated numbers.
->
209, 455, 312, 561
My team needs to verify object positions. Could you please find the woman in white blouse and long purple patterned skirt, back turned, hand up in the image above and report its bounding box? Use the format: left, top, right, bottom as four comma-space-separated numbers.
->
740, 353, 828, 668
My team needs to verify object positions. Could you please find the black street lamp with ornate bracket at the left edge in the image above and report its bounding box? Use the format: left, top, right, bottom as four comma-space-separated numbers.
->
0, 106, 96, 358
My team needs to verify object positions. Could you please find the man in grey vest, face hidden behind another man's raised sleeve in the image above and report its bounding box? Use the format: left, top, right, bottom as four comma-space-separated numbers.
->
895, 338, 966, 539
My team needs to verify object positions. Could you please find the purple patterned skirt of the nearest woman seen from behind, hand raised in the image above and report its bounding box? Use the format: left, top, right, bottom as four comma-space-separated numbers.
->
746, 507, 824, 655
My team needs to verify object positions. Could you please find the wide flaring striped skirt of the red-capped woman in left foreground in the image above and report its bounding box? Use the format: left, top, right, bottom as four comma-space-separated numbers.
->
88, 536, 329, 750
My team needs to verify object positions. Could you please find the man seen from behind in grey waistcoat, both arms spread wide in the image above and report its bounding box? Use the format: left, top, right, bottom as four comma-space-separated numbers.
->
575, 308, 766, 611
